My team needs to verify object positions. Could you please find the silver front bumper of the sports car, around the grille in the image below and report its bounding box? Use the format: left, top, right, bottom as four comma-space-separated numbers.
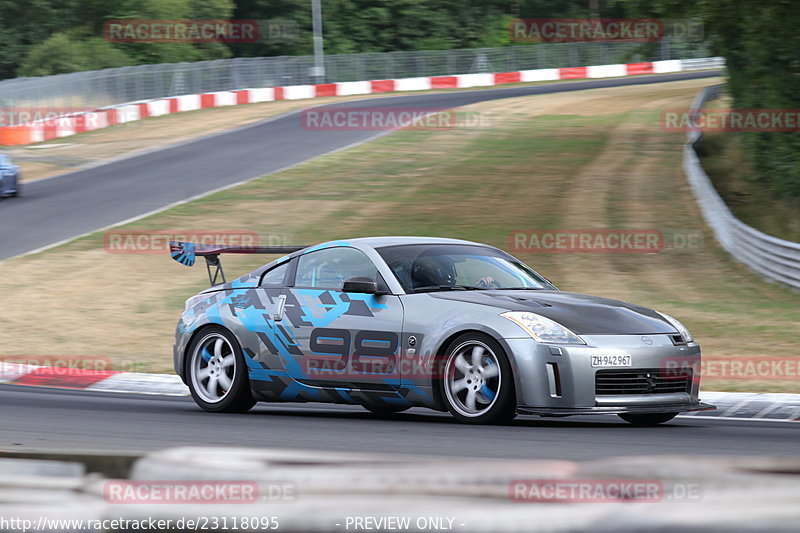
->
504, 335, 714, 416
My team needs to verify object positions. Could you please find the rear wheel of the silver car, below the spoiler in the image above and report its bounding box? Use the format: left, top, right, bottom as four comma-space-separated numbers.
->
186, 326, 256, 413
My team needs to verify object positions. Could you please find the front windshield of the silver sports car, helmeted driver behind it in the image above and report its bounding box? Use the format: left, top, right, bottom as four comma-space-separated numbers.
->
377, 244, 555, 293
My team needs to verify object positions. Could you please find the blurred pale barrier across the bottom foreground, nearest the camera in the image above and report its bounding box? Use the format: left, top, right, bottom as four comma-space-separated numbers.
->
0, 447, 800, 533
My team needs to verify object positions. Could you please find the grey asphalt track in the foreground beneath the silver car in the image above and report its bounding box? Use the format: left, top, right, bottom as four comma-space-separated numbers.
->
0, 385, 800, 461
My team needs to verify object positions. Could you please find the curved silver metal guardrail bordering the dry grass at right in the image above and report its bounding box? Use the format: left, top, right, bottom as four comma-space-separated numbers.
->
683, 85, 800, 289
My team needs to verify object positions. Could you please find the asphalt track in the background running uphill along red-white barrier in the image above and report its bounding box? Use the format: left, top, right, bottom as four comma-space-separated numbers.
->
0, 71, 720, 260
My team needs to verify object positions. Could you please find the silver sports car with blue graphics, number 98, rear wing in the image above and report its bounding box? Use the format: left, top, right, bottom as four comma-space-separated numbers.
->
171, 237, 714, 425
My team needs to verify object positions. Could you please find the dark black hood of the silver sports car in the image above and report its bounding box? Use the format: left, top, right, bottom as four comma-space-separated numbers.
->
428, 290, 676, 335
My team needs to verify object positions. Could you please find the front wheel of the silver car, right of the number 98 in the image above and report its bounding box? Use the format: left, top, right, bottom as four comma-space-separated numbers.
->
438, 333, 517, 424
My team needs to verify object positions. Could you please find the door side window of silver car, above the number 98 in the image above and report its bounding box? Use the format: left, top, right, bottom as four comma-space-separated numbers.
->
294, 248, 378, 290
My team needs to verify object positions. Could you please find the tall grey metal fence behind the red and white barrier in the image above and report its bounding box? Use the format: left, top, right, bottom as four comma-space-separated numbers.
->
0, 39, 709, 108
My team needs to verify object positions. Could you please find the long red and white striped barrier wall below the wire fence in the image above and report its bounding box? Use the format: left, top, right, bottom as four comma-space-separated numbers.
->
0, 58, 724, 146
